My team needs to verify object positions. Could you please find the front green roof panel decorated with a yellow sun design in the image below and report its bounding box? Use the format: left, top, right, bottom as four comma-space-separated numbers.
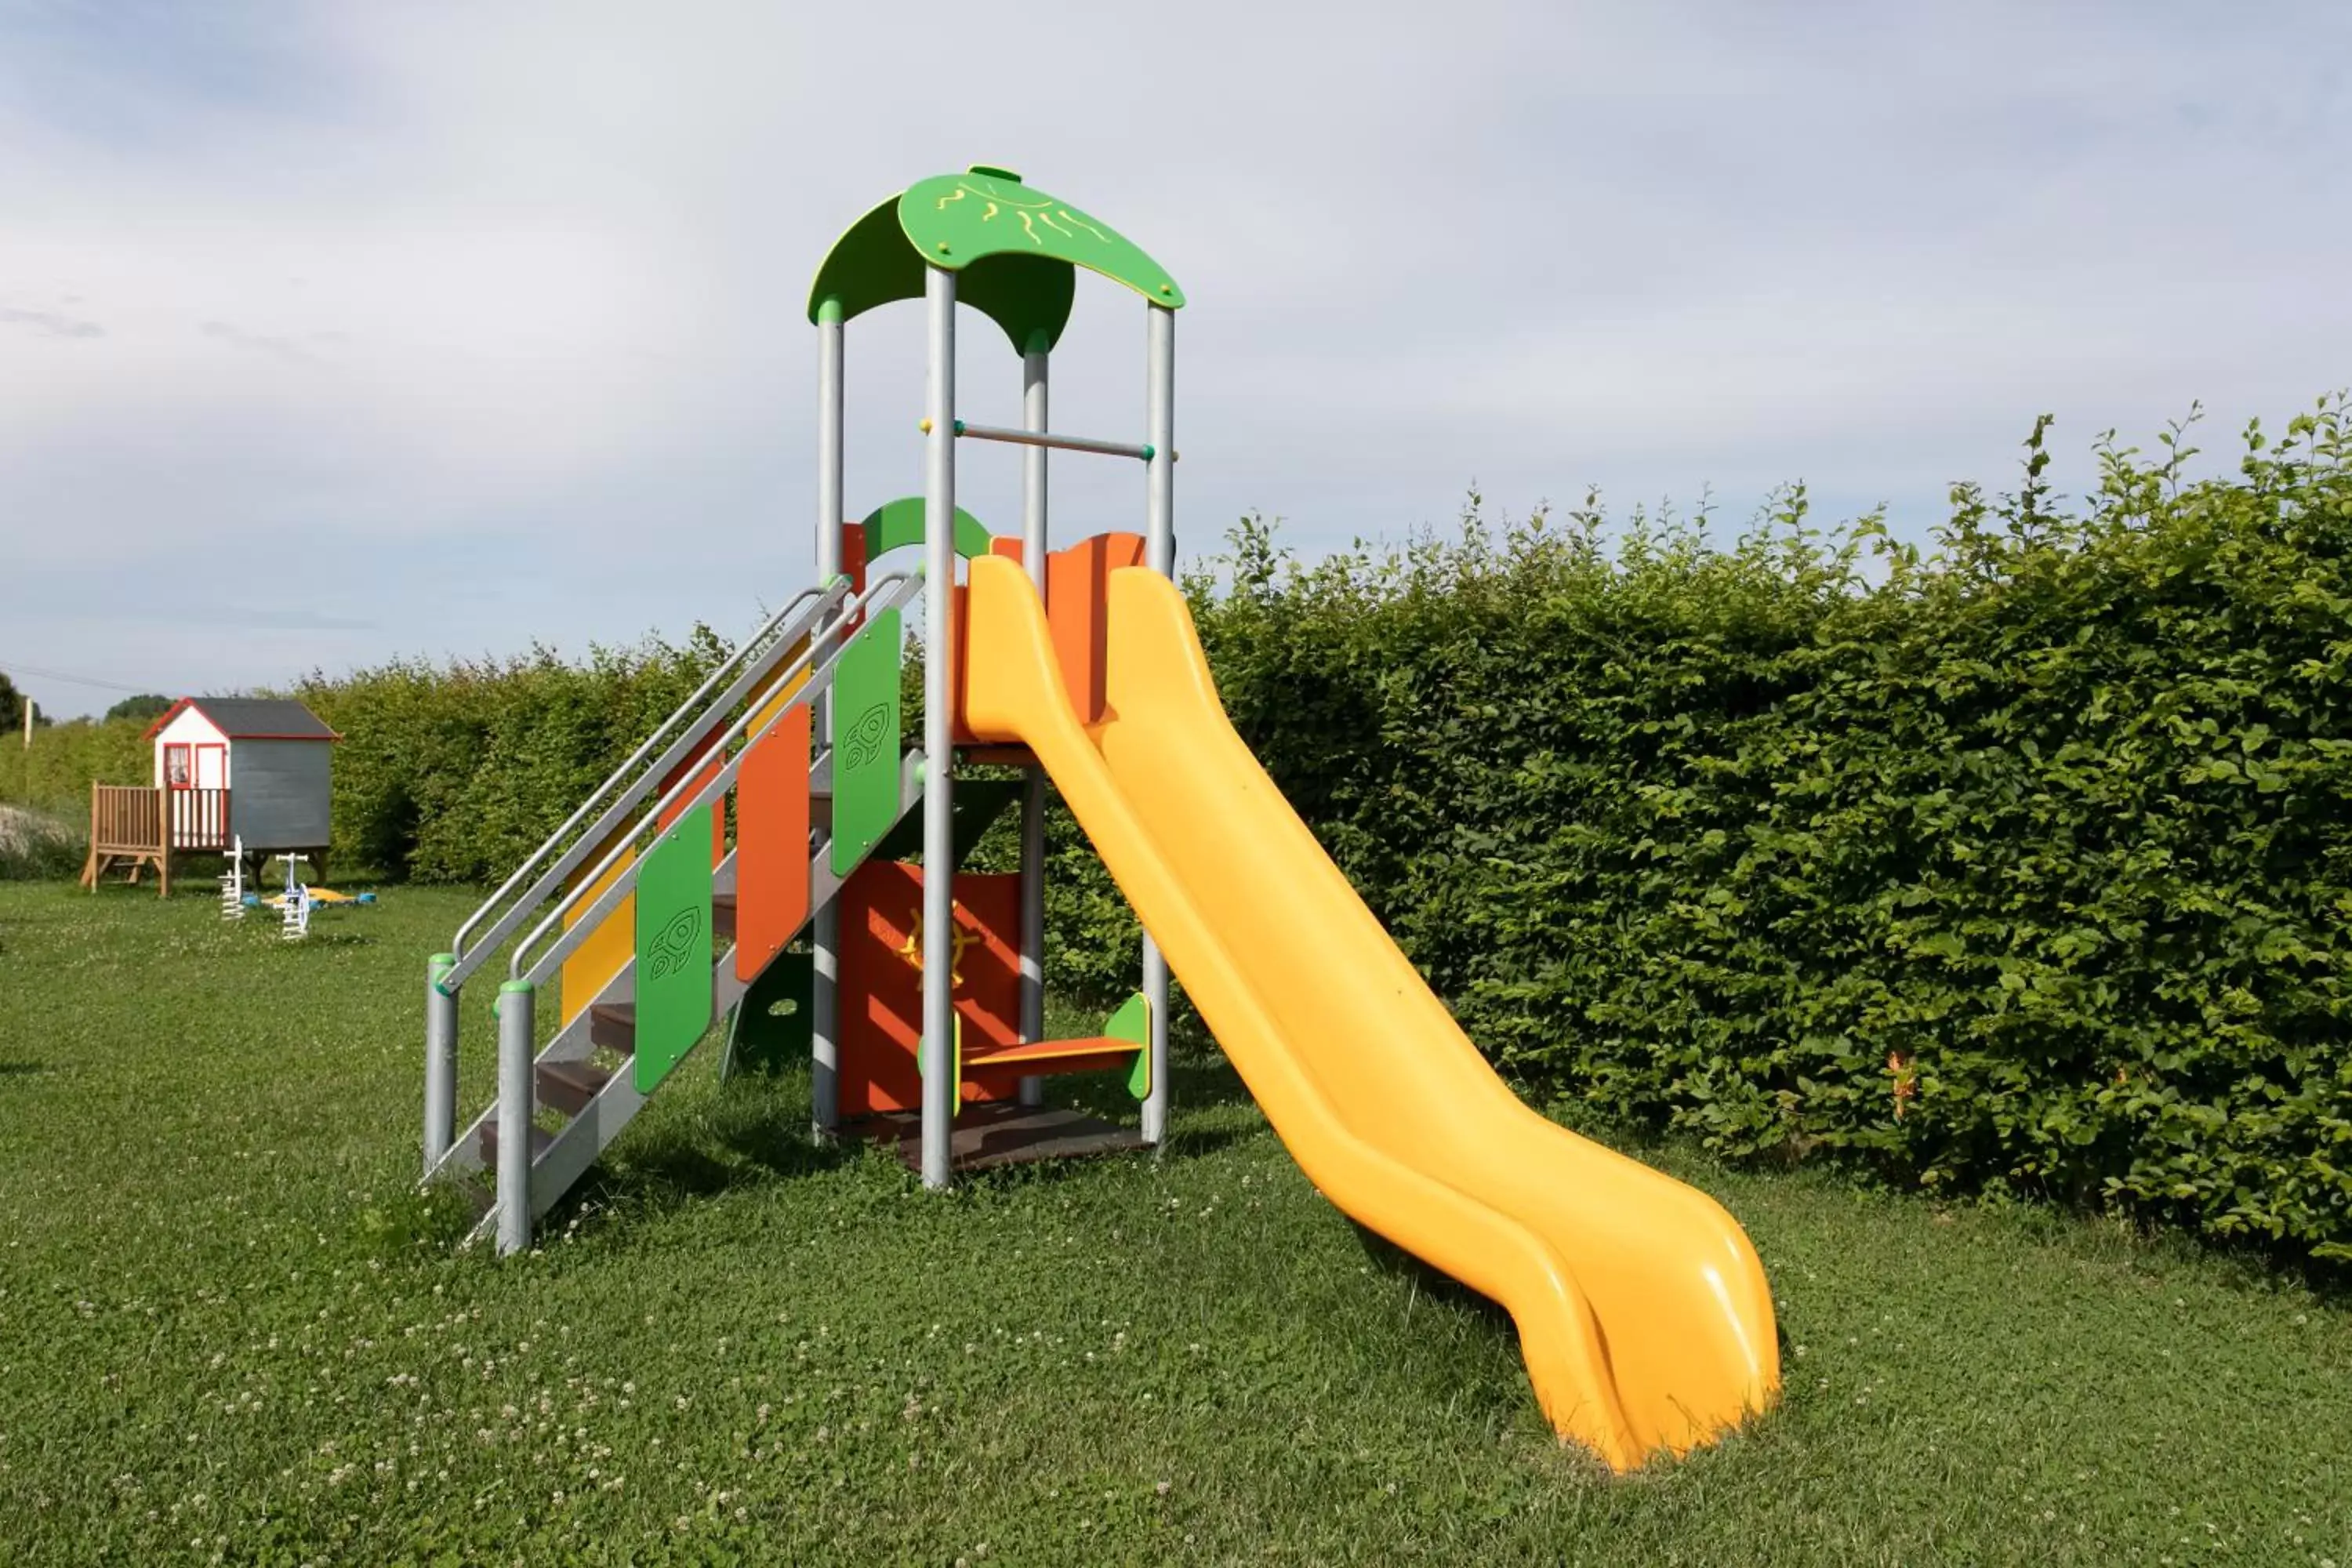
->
903, 169, 1183, 310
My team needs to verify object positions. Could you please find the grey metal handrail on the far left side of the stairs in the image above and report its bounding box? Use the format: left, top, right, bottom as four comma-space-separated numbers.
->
437, 579, 849, 992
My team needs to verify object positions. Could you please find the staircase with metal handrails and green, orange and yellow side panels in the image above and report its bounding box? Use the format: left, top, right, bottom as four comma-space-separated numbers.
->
423, 574, 924, 1250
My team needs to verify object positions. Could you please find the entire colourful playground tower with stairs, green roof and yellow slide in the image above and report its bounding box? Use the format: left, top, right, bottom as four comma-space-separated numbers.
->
423, 167, 1778, 1469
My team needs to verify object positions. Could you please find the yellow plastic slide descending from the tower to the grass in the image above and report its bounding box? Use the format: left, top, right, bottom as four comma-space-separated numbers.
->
967, 557, 1780, 1469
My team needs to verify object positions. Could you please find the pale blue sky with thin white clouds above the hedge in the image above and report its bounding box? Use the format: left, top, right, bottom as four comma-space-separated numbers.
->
0, 0, 2352, 715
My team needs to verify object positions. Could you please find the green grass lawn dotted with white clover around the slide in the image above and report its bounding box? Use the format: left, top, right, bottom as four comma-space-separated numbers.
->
0, 884, 2352, 1568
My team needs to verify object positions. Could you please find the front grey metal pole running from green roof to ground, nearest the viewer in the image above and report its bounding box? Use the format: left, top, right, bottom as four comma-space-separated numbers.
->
922, 266, 955, 1189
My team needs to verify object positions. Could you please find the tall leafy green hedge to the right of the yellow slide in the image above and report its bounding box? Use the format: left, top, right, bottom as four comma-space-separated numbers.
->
1152, 402, 2352, 1258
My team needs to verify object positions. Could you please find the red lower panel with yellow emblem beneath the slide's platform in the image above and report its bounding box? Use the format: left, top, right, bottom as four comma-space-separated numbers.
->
840, 862, 1021, 1116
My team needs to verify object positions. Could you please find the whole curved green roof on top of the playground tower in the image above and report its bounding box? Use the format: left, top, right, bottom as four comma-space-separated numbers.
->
809, 165, 1183, 353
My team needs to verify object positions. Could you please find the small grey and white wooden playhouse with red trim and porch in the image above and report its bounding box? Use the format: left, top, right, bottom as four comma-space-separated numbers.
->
82, 696, 341, 893
